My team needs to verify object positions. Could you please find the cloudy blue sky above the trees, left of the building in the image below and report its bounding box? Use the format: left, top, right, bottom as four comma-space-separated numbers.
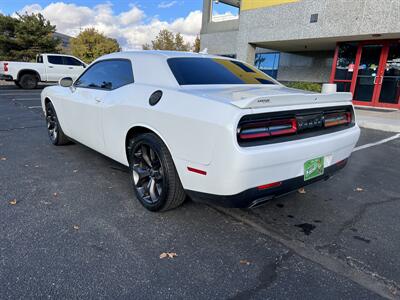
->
14, 1, 202, 50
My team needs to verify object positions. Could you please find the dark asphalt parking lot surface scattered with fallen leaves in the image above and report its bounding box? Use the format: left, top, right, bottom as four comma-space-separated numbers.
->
0, 85, 400, 299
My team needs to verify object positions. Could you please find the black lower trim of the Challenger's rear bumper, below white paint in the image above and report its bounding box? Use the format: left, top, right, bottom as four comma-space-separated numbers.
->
186, 159, 347, 208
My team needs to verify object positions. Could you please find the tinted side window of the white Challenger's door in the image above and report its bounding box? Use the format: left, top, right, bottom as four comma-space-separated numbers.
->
75, 59, 134, 90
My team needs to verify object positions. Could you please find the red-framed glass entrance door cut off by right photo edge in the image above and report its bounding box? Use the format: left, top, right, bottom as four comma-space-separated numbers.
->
377, 41, 400, 108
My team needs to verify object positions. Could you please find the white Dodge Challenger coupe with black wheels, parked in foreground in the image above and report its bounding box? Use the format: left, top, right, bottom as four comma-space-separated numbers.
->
41, 51, 360, 211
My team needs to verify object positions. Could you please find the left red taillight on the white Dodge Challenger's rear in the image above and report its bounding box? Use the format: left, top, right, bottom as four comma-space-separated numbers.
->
238, 118, 297, 140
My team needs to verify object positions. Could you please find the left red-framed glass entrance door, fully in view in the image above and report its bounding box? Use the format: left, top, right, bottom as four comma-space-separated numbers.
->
353, 44, 384, 105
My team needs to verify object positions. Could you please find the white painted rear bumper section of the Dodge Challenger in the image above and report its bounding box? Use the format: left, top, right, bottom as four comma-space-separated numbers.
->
175, 126, 360, 196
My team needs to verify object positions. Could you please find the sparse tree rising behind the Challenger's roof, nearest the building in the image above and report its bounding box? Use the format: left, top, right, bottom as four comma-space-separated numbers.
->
142, 29, 190, 51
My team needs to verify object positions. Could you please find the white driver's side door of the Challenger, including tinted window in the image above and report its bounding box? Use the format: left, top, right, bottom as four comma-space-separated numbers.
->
64, 59, 133, 153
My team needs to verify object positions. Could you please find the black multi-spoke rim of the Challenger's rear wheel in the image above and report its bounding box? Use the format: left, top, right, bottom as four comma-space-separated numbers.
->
132, 143, 164, 205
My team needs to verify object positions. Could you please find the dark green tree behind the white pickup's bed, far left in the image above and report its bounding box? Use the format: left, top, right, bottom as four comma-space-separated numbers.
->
0, 14, 61, 61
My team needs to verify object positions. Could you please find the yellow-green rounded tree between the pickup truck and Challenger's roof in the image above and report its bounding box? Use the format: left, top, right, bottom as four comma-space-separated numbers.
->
71, 28, 121, 63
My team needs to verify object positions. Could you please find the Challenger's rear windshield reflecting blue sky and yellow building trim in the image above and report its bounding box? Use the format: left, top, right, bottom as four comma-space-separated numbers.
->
168, 57, 275, 85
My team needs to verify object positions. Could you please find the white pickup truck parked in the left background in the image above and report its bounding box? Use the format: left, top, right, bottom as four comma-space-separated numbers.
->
0, 53, 86, 89
